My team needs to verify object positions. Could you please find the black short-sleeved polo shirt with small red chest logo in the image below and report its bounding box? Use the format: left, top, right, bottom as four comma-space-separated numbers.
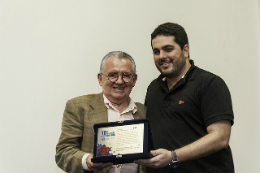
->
145, 60, 234, 173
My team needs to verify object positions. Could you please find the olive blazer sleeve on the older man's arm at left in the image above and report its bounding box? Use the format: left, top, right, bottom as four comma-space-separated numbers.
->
55, 101, 85, 173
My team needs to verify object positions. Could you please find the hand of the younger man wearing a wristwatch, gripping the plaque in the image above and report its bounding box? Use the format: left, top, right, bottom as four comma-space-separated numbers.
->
134, 149, 172, 168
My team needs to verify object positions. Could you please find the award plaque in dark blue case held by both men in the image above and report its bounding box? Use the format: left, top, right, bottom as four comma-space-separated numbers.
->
91, 119, 154, 164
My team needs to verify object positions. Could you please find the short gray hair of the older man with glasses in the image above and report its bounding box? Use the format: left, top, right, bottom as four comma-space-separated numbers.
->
99, 51, 136, 75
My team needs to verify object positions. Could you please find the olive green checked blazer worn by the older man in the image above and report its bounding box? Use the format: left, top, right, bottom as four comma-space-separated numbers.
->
55, 93, 145, 173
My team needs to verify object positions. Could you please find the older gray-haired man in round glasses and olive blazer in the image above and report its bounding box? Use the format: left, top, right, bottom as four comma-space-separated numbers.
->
56, 51, 145, 173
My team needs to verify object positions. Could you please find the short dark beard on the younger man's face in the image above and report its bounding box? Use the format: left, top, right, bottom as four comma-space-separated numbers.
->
156, 54, 186, 77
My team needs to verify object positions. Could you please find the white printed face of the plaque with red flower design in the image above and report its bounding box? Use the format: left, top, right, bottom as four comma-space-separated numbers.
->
96, 124, 144, 157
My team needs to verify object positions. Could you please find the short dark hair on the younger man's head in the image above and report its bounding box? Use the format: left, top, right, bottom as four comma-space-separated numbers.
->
151, 22, 189, 50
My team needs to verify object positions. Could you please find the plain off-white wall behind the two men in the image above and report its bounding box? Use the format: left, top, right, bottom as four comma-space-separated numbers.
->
0, 0, 260, 173
